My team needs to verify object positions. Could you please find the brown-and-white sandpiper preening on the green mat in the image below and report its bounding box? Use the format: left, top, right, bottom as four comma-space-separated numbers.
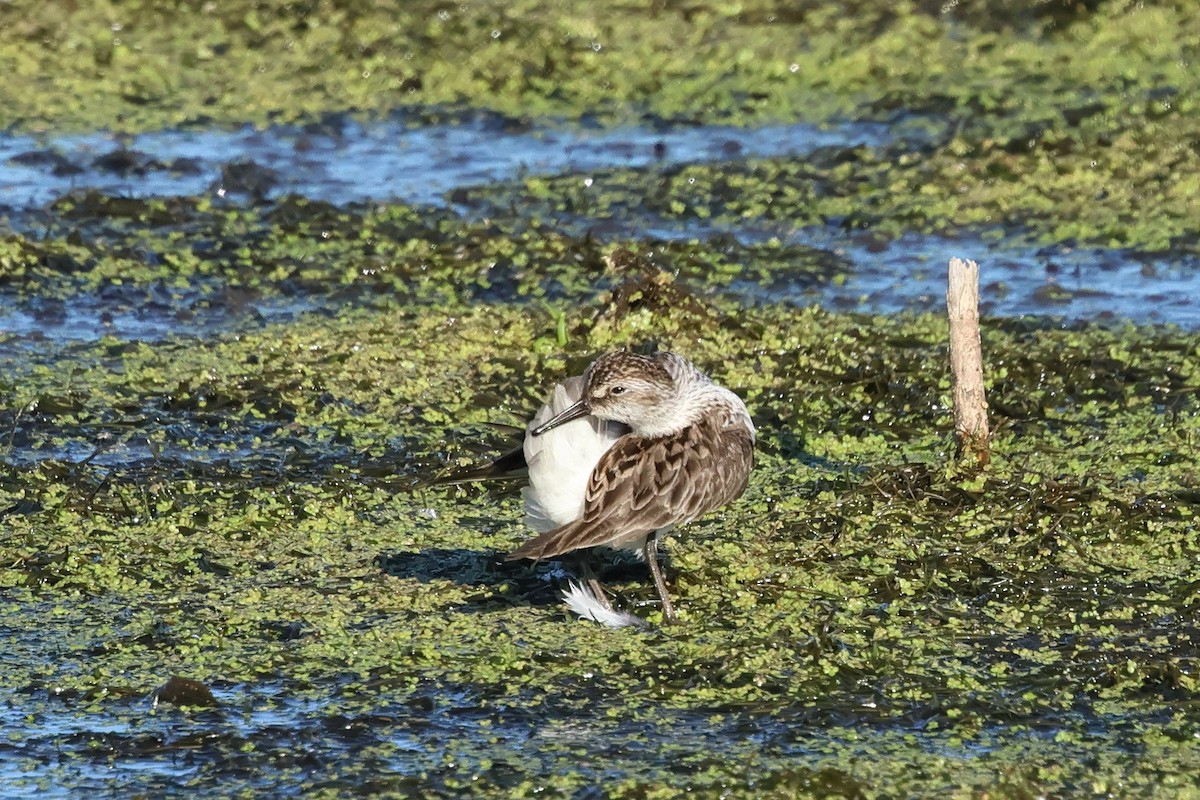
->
508, 351, 755, 625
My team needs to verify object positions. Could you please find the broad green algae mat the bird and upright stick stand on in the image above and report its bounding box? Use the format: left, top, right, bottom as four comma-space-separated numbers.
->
0, 275, 1200, 796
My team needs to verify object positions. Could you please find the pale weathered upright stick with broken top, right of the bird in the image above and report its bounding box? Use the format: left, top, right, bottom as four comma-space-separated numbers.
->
946, 258, 991, 468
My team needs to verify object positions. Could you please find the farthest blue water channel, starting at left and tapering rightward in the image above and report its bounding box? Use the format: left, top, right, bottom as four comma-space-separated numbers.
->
0, 115, 890, 210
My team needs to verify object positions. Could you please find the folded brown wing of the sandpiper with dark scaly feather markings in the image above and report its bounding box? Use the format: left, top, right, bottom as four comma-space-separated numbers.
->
509, 420, 754, 560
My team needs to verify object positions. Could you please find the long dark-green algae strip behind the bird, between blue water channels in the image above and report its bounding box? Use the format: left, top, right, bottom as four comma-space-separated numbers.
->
0, 193, 845, 319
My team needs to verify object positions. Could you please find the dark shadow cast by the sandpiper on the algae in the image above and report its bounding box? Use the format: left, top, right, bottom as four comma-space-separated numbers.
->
374, 547, 647, 613
